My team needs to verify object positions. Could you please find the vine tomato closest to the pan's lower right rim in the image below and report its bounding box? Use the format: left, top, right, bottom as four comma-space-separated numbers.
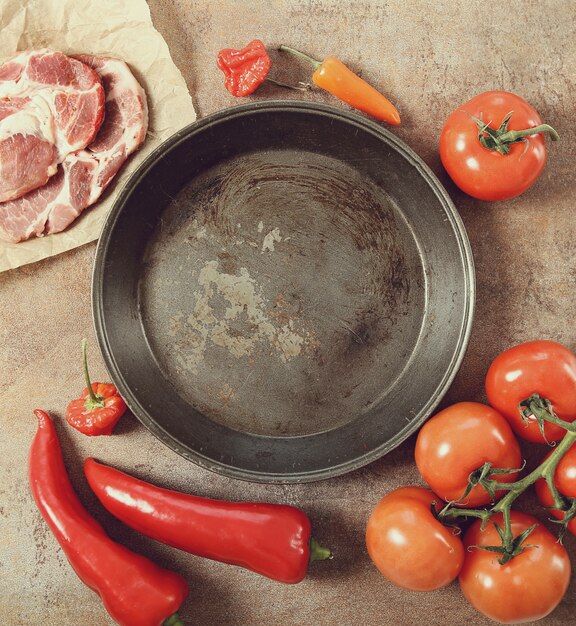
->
415, 402, 522, 507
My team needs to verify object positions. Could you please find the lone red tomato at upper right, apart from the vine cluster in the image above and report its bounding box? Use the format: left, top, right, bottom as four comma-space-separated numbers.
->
440, 91, 557, 200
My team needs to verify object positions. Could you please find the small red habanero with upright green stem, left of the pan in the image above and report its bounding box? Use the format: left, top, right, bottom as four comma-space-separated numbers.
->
66, 339, 126, 436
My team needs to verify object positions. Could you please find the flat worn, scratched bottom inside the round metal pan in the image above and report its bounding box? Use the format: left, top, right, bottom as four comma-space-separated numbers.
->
139, 149, 425, 436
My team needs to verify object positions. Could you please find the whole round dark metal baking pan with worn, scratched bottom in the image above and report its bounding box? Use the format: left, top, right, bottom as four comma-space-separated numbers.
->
93, 101, 474, 482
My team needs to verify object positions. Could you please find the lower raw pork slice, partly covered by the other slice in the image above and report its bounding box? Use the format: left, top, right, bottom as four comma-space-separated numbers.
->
0, 55, 148, 242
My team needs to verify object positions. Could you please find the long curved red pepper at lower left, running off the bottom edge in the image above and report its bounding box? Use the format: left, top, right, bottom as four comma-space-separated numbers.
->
28, 410, 188, 626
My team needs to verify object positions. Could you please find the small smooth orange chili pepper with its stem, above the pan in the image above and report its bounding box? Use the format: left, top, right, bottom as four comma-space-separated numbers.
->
279, 45, 400, 126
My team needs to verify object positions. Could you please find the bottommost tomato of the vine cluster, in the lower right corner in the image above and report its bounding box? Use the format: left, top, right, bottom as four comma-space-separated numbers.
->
459, 511, 571, 624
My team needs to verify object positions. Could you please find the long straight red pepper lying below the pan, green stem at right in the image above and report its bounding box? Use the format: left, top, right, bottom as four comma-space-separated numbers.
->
84, 458, 331, 583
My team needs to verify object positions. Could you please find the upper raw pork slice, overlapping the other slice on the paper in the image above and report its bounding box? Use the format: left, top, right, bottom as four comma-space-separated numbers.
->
0, 49, 104, 202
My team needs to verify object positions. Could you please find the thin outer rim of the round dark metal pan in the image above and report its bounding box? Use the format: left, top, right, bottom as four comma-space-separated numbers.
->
91, 100, 476, 484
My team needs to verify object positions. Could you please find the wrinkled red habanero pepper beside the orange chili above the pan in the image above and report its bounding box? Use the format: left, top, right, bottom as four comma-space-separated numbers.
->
217, 39, 270, 97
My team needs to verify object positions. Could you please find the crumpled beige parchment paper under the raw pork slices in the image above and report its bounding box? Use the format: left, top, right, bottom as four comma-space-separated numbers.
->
0, 0, 196, 271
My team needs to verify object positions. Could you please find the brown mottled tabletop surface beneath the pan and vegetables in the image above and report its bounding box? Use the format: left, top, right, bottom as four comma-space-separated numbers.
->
0, 0, 576, 626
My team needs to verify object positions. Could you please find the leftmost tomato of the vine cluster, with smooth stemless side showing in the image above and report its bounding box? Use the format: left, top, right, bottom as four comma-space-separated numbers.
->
366, 487, 464, 591
